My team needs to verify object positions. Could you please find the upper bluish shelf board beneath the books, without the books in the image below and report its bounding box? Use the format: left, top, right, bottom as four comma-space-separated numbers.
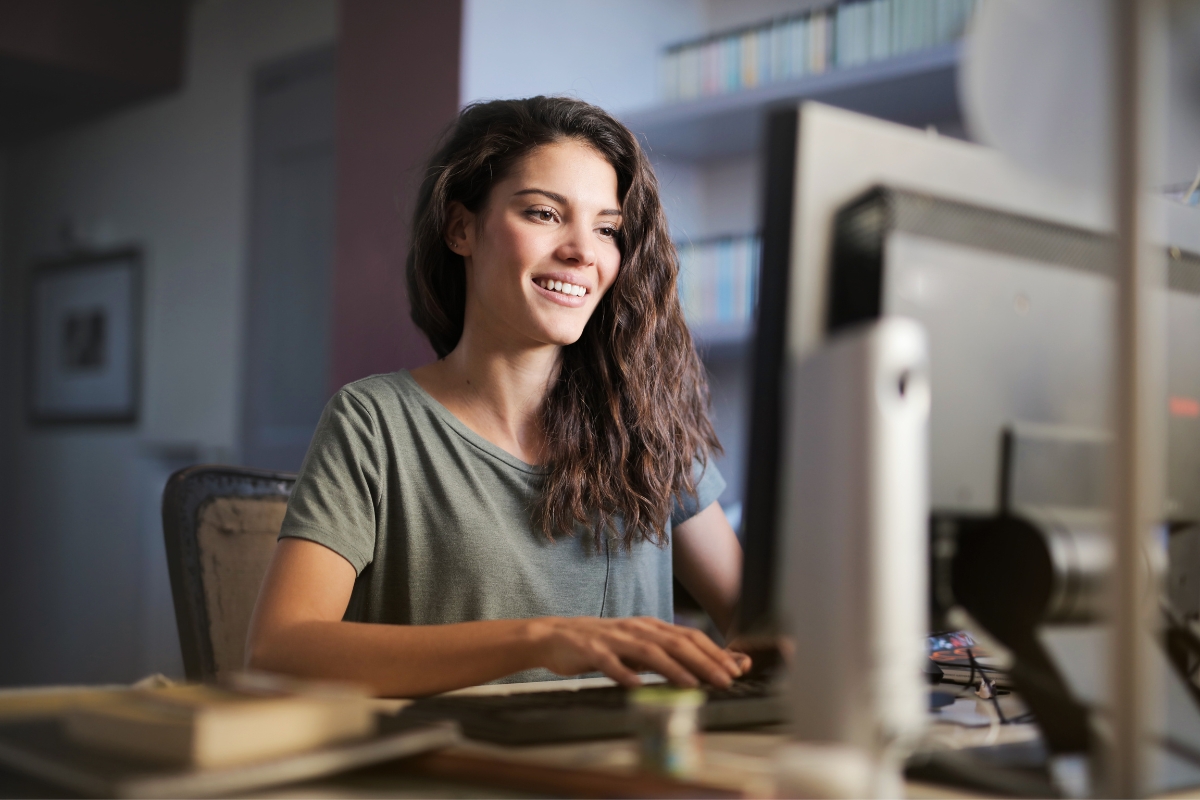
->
623, 42, 961, 161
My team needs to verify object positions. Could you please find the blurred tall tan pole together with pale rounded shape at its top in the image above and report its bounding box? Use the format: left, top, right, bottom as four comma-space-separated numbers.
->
962, 0, 1176, 796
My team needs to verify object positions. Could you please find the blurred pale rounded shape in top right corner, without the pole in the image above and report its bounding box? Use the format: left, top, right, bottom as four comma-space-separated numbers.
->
959, 0, 1200, 193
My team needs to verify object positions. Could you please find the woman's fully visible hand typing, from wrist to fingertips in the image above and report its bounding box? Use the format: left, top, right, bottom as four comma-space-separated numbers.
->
530, 616, 750, 687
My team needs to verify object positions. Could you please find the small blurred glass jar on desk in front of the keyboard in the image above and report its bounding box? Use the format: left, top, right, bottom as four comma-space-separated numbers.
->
629, 686, 704, 778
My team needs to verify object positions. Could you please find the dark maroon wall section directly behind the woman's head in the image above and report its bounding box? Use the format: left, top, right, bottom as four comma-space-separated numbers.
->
330, 0, 458, 390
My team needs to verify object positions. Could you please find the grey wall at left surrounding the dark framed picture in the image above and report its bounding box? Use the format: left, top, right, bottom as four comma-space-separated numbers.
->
0, 0, 337, 684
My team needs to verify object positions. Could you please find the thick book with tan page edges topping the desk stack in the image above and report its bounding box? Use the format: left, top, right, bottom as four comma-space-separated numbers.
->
64, 685, 376, 769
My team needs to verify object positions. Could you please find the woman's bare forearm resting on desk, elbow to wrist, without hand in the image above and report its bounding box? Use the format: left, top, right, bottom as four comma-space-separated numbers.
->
247, 620, 549, 697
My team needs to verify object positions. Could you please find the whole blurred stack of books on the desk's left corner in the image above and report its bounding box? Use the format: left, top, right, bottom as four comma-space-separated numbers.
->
0, 676, 458, 798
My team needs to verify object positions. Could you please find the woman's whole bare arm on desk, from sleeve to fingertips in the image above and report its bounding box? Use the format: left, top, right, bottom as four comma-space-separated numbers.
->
246, 537, 743, 697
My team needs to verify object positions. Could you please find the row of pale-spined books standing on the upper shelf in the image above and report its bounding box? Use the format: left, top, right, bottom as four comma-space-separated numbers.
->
662, 0, 979, 102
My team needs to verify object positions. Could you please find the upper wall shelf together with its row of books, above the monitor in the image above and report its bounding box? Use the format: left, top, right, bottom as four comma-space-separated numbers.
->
625, 0, 979, 161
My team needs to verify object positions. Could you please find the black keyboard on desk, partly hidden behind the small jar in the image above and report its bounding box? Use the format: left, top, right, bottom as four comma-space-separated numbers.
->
398, 678, 785, 745
